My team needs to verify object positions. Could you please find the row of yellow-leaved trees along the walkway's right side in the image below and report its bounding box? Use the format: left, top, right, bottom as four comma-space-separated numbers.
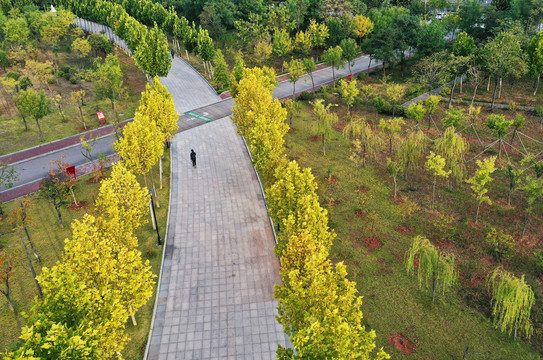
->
233, 68, 389, 359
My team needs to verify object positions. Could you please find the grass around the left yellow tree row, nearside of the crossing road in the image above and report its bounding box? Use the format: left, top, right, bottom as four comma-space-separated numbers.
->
0, 152, 170, 360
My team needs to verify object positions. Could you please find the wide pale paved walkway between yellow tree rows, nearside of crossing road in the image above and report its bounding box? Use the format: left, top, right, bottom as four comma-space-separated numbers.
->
146, 118, 289, 360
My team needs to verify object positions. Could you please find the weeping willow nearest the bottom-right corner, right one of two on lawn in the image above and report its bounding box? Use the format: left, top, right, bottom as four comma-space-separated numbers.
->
487, 267, 535, 340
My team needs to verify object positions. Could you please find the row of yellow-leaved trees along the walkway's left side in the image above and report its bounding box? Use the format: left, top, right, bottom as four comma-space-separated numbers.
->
5, 78, 179, 360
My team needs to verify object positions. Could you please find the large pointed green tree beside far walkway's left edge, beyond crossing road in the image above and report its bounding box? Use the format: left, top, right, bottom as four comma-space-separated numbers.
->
134, 24, 172, 78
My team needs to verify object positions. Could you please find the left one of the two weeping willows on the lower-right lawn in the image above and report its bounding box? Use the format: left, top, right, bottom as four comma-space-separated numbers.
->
406, 235, 457, 302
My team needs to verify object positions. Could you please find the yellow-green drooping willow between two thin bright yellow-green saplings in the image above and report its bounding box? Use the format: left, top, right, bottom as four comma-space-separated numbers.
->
436, 126, 468, 191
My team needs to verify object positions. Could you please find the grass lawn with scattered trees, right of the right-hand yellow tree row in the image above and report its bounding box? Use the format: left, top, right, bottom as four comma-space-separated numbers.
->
286, 99, 541, 359
